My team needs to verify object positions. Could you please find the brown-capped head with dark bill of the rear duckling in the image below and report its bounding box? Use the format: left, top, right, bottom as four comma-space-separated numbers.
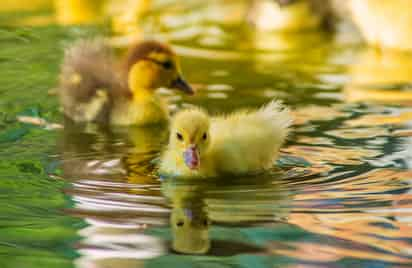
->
125, 41, 193, 94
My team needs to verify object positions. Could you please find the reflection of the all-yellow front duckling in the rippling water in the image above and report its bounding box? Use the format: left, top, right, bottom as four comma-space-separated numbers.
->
161, 172, 293, 256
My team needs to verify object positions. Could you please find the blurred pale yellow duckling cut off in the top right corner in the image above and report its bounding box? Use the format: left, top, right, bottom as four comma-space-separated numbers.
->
347, 0, 412, 50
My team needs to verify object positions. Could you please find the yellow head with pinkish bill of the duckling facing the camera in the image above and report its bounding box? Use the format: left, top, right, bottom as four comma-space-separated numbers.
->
169, 108, 210, 170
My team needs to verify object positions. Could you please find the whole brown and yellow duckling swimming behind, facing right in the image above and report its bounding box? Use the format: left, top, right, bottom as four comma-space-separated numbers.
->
59, 40, 193, 126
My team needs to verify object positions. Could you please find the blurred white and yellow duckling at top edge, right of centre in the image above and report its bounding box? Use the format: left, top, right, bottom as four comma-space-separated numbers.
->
248, 0, 332, 32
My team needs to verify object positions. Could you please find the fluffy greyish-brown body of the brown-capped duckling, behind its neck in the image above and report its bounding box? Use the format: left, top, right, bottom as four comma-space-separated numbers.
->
59, 39, 122, 121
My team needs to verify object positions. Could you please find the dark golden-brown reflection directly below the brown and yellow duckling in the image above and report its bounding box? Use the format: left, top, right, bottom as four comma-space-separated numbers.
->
60, 121, 168, 183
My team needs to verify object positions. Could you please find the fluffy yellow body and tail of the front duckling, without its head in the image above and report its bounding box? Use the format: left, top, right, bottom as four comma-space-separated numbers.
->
210, 101, 292, 173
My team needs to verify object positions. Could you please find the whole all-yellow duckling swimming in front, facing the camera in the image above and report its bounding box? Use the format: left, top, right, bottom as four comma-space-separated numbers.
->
159, 101, 292, 178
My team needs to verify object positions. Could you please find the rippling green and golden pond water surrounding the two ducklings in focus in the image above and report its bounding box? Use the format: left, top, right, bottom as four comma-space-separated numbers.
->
0, 2, 412, 268
